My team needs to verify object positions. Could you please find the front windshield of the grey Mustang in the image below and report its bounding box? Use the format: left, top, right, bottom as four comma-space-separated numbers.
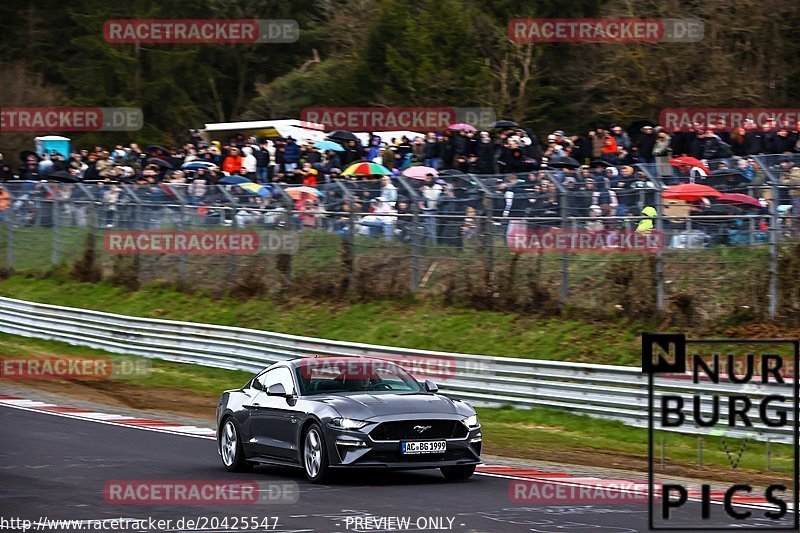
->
295, 357, 424, 396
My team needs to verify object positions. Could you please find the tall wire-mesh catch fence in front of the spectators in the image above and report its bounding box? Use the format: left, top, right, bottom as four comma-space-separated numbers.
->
0, 156, 800, 322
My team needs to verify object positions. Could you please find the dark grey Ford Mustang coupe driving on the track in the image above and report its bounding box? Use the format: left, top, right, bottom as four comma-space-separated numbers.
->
212, 357, 481, 482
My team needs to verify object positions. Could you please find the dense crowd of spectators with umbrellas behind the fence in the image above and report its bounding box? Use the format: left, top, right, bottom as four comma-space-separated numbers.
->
0, 116, 800, 245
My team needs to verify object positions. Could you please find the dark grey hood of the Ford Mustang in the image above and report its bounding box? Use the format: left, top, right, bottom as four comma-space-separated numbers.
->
313, 393, 473, 420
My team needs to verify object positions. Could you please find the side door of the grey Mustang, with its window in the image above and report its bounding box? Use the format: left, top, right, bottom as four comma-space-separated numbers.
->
247, 366, 299, 461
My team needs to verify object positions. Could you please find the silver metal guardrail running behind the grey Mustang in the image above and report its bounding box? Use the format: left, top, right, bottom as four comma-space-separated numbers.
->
0, 298, 792, 443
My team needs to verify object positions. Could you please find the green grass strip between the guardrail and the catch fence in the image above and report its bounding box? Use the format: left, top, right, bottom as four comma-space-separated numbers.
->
0, 275, 648, 365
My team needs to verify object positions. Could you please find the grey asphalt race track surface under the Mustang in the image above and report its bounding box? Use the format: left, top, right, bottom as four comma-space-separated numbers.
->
0, 407, 792, 533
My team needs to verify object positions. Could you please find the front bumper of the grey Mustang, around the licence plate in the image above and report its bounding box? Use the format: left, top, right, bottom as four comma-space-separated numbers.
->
326, 427, 483, 470
